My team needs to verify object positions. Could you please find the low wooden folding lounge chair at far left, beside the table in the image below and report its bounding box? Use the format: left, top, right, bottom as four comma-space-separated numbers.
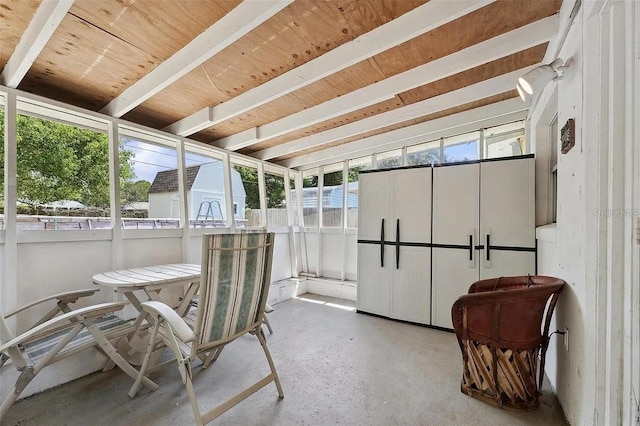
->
0, 289, 158, 420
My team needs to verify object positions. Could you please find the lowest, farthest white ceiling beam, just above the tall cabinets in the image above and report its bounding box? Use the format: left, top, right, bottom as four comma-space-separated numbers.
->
279, 98, 529, 170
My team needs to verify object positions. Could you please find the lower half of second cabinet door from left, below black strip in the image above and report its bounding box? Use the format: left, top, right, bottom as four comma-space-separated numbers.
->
385, 247, 431, 324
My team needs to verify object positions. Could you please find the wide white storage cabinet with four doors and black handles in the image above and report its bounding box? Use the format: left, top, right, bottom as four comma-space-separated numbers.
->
357, 156, 535, 328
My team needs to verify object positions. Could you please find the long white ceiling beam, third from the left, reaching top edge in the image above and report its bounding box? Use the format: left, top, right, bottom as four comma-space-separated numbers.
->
163, 0, 495, 136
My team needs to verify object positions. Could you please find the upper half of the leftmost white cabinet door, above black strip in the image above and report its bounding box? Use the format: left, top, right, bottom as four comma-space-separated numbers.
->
358, 172, 395, 241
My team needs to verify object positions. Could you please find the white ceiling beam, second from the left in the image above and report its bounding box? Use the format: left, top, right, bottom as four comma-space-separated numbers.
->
100, 0, 293, 117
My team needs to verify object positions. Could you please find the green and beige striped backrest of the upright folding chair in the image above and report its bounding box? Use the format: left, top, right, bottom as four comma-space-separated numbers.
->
196, 232, 273, 344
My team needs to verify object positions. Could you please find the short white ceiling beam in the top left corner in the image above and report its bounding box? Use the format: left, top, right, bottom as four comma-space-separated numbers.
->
0, 0, 73, 89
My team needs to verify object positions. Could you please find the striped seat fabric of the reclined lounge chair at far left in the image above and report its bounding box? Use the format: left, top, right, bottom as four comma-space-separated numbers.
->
22, 314, 131, 363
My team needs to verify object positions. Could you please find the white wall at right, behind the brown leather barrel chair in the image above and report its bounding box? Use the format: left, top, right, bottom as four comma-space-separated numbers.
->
529, 1, 638, 425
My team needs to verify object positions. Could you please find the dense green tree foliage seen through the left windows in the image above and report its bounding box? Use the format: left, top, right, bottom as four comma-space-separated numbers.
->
0, 110, 135, 208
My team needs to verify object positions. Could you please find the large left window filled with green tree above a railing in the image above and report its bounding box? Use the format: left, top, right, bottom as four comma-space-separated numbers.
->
10, 113, 112, 230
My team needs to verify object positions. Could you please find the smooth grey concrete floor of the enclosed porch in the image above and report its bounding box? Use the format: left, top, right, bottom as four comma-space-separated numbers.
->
2, 294, 566, 426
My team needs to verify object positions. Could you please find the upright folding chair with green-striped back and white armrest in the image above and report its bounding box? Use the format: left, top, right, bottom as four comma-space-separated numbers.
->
129, 232, 284, 425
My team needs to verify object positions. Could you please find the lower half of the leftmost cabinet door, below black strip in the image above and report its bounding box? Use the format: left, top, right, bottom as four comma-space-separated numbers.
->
356, 244, 395, 317
